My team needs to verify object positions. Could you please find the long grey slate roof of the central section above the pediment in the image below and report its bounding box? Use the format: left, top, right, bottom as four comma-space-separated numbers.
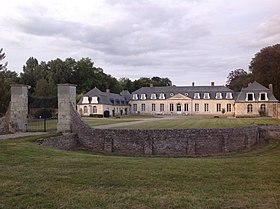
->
132, 86, 237, 99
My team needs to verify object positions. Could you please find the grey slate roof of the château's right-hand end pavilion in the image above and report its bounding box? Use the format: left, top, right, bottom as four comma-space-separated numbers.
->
236, 81, 278, 102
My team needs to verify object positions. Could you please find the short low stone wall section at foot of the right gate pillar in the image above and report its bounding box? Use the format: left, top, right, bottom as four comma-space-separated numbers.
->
37, 133, 79, 150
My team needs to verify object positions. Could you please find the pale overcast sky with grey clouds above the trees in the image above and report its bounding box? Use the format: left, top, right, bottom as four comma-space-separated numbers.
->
0, 0, 280, 85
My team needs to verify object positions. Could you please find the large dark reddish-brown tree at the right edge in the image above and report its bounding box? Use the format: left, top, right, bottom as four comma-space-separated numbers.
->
249, 44, 280, 100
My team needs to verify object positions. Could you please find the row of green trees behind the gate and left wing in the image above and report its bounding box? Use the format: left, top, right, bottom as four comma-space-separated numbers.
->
0, 49, 172, 115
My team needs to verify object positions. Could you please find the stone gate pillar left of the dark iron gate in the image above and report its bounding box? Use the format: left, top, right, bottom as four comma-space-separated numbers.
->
9, 84, 29, 132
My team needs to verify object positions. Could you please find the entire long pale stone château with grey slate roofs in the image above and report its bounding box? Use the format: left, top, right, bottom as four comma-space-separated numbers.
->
78, 82, 278, 117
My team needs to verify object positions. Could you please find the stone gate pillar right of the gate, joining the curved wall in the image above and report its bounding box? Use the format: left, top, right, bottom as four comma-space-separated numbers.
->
57, 84, 76, 133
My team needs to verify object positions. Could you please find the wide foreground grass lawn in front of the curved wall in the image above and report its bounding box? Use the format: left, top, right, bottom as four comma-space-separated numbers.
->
0, 136, 280, 209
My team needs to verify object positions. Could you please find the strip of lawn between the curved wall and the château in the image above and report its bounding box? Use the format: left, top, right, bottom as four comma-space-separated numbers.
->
117, 116, 280, 129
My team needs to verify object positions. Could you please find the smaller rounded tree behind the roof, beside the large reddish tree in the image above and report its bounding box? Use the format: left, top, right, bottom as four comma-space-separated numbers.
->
226, 69, 254, 91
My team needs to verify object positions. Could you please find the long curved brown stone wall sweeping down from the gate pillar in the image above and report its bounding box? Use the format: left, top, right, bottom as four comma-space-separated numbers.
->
66, 105, 267, 156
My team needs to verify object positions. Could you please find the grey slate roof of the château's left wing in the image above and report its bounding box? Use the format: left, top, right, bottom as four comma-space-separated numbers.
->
78, 87, 130, 105
